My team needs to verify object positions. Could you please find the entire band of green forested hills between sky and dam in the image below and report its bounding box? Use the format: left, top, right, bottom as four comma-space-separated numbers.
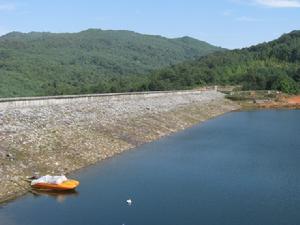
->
0, 30, 300, 97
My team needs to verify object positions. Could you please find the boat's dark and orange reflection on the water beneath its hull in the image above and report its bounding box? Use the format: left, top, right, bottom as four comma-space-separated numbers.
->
31, 189, 79, 203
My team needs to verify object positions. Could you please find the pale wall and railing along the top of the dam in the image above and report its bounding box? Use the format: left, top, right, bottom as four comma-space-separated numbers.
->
0, 87, 216, 109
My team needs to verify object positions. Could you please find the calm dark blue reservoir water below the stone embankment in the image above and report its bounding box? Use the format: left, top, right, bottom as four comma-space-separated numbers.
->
0, 110, 300, 225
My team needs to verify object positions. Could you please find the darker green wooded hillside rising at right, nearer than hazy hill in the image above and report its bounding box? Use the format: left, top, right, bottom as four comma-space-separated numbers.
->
146, 31, 300, 93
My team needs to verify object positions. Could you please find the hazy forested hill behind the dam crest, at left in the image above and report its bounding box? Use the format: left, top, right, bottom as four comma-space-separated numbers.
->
0, 29, 223, 97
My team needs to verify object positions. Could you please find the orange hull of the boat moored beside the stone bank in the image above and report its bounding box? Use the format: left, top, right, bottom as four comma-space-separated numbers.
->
31, 180, 79, 191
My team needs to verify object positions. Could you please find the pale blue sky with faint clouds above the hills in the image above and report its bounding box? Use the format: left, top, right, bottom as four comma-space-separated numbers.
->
0, 0, 300, 48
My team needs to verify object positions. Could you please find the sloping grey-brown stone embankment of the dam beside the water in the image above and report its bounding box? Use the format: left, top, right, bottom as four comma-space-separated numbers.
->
0, 91, 239, 201
